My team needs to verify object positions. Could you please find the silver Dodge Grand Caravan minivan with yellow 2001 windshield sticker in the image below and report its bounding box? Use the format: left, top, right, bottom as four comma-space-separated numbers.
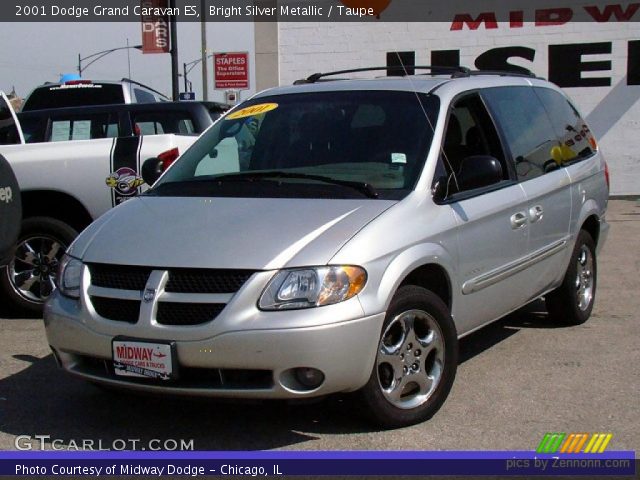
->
45, 68, 608, 427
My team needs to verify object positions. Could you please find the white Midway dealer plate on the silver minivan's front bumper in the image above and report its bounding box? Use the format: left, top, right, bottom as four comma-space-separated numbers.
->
112, 339, 176, 380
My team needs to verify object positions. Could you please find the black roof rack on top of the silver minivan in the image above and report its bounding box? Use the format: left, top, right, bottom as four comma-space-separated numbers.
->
293, 65, 537, 85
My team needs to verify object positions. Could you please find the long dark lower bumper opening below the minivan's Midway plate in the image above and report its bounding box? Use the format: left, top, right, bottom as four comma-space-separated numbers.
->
72, 355, 273, 390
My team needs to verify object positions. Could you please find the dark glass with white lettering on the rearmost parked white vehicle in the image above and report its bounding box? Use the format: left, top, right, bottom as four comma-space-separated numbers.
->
22, 83, 124, 112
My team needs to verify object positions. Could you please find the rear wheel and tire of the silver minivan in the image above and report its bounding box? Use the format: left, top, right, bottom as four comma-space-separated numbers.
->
545, 230, 598, 325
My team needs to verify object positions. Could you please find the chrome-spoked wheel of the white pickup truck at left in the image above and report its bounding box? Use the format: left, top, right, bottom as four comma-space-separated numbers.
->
0, 217, 78, 313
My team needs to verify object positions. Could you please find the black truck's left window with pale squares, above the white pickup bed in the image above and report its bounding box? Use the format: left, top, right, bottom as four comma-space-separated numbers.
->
49, 113, 118, 142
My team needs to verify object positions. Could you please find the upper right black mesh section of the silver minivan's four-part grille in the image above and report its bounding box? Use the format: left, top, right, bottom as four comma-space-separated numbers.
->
165, 268, 255, 293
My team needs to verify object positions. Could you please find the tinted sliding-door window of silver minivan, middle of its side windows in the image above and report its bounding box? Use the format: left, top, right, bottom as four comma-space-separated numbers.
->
482, 87, 559, 180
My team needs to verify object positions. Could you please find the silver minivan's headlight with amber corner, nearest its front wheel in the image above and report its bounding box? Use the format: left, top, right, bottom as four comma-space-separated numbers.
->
258, 266, 367, 310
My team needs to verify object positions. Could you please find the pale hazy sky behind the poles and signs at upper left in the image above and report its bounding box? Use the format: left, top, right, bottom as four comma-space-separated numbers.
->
0, 22, 255, 101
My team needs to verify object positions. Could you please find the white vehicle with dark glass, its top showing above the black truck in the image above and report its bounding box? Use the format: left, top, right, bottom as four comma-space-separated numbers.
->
22, 78, 169, 112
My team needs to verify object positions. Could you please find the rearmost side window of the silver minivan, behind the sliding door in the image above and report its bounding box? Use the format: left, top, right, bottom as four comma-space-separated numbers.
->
534, 88, 596, 165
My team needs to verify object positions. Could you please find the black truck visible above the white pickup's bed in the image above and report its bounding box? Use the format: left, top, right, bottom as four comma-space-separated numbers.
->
18, 102, 230, 143
